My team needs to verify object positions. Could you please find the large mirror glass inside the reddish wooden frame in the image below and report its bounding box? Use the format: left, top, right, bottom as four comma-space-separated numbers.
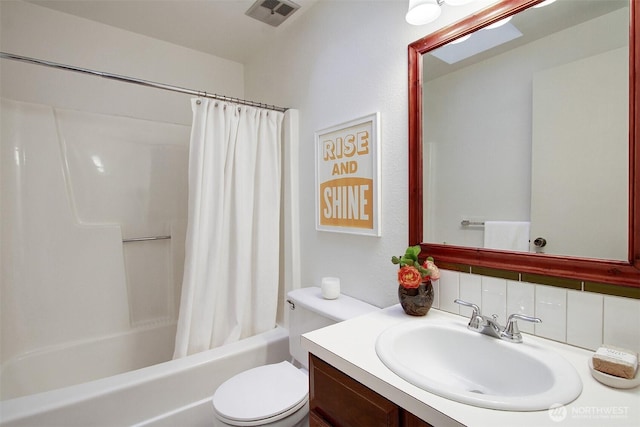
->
422, 0, 629, 260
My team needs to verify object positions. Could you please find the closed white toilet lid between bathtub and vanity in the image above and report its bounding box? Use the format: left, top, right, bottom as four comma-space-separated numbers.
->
213, 362, 309, 425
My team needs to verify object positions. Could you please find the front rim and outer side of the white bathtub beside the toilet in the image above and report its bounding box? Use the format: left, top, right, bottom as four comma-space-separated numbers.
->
0, 327, 290, 427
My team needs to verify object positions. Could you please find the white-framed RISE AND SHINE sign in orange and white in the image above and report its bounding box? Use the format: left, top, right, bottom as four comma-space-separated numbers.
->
315, 113, 380, 236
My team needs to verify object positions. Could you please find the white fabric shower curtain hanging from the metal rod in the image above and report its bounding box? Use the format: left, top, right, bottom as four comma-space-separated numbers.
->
174, 99, 284, 358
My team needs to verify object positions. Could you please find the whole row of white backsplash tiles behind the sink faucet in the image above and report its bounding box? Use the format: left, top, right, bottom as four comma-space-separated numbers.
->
433, 270, 640, 352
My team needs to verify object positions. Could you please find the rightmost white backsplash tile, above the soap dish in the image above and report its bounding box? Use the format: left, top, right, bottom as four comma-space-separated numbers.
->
603, 296, 640, 352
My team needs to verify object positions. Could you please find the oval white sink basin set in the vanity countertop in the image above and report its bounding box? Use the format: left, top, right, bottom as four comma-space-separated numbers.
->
376, 320, 582, 411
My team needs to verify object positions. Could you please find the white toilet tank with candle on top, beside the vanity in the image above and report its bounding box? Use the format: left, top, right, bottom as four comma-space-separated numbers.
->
287, 287, 379, 369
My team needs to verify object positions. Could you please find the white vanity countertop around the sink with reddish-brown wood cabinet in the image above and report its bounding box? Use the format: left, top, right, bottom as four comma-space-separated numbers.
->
302, 305, 640, 427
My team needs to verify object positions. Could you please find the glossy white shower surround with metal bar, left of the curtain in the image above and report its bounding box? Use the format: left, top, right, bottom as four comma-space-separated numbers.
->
0, 98, 190, 400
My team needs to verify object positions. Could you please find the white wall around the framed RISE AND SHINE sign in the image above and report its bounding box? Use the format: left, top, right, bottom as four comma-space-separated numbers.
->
245, 0, 492, 306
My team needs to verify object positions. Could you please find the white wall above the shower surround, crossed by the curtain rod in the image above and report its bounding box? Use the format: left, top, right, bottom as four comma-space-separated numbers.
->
0, 0, 244, 124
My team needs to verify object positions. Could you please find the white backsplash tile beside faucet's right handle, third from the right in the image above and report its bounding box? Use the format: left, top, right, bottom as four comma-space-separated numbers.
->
536, 285, 567, 342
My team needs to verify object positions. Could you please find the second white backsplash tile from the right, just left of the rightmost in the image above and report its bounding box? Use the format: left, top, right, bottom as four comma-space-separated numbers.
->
567, 290, 604, 350
